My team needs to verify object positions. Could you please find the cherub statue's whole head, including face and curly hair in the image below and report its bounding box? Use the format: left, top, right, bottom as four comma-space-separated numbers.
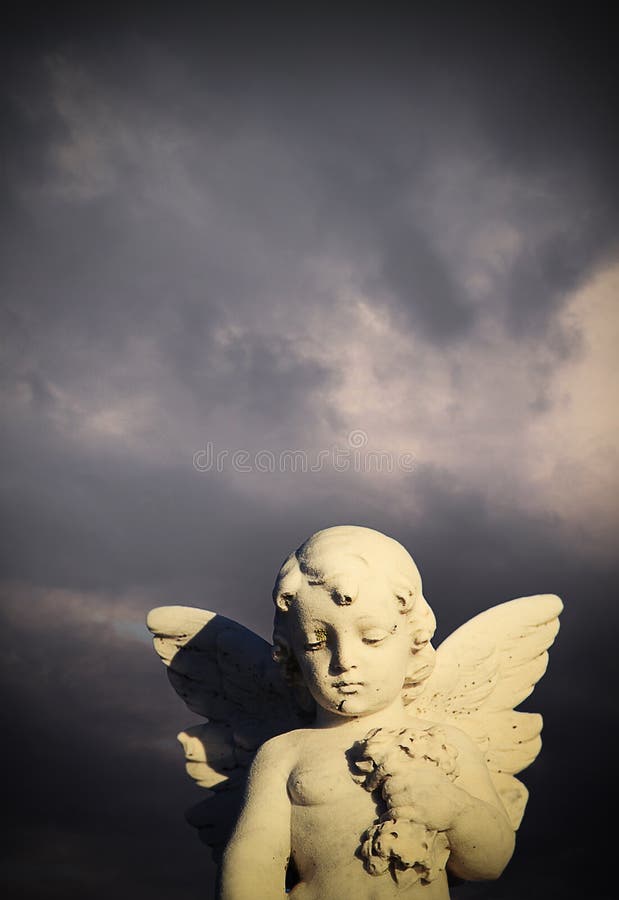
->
273, 525, 436, 716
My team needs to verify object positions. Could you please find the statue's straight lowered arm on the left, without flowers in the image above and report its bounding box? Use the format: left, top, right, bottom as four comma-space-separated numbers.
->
220, 738, 291, 900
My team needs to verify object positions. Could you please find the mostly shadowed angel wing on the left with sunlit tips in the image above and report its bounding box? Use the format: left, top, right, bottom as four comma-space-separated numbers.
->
146, 606, 304, 859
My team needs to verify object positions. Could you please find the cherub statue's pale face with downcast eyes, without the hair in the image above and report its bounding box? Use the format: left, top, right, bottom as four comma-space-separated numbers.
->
287, 578, 411, 716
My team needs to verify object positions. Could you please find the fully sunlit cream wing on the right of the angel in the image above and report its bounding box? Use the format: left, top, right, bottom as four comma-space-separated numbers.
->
417, 594, 563, 829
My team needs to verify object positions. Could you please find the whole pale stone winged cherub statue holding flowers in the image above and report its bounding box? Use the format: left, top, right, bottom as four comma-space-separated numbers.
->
148, 525, 562, 900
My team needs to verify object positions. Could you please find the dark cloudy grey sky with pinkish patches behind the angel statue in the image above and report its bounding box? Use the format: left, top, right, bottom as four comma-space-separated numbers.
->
0, 3, 619, 900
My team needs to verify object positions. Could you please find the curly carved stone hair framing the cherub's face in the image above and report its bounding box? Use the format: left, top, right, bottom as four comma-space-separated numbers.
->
273, 525, 436, 708
